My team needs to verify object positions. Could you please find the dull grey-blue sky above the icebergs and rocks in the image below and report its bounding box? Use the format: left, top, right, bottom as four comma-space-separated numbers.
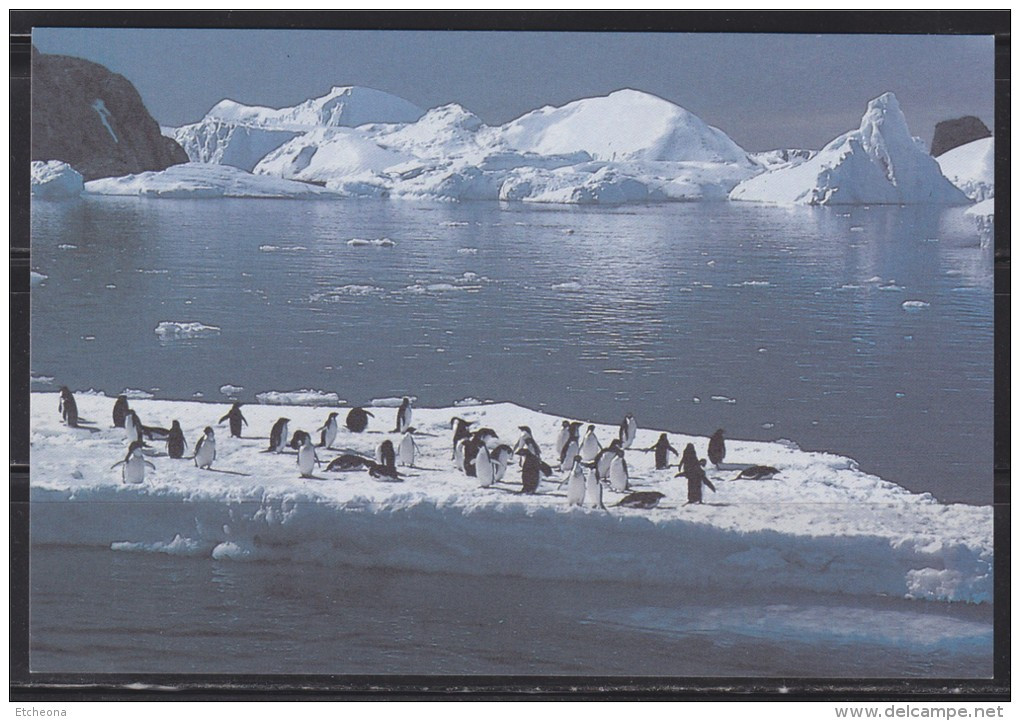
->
33, 29, 995, 151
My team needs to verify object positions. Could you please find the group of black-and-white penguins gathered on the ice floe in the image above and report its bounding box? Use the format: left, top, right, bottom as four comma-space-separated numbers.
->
59, 387, 779, 510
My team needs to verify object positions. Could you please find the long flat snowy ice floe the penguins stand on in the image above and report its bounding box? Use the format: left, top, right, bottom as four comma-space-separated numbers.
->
32, 393, 992, 603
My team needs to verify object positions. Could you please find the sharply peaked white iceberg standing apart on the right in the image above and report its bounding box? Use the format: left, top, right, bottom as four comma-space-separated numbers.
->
729, 93, 968, 205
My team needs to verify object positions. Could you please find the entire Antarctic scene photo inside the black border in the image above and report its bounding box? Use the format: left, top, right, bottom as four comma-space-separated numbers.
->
30, 29, 995, 679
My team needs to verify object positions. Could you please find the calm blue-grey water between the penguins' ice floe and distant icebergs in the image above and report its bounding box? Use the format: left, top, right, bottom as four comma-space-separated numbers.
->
32, 198, 992, 504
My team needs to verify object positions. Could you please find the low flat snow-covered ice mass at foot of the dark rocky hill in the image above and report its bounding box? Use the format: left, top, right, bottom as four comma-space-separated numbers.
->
85, 163, 337, 198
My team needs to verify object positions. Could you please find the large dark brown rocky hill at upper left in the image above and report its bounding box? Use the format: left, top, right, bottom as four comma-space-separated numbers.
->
32, 48, 188, 181
